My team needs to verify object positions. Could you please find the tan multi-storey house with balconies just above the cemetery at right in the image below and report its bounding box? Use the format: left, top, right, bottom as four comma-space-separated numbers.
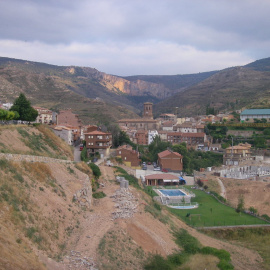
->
223, 143, 252, 165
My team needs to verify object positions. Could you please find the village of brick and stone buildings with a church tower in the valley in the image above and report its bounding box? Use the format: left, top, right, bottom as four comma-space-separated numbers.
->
1, 102, 270, 189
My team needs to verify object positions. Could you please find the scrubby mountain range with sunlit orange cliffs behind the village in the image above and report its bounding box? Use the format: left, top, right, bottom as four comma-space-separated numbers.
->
0, 57, 270, 124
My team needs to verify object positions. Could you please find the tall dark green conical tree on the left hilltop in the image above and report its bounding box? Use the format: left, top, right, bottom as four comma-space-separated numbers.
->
10, 93, 38, 122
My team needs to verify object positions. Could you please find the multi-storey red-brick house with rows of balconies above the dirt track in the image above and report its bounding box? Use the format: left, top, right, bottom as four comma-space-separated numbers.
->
84, 130, 112, 157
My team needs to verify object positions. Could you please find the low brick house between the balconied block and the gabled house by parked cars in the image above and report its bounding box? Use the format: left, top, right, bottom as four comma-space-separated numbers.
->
116, 145, 141, 168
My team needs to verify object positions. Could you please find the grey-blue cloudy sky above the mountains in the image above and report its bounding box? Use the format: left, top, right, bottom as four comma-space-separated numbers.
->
0, 0, 270, 76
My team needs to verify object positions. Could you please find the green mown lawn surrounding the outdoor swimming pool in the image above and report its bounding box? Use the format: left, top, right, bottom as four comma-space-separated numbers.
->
168, 189, 269, 227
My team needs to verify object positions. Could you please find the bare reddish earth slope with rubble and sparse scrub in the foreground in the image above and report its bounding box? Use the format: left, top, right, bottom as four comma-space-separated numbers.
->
0, 128, 266, 270
